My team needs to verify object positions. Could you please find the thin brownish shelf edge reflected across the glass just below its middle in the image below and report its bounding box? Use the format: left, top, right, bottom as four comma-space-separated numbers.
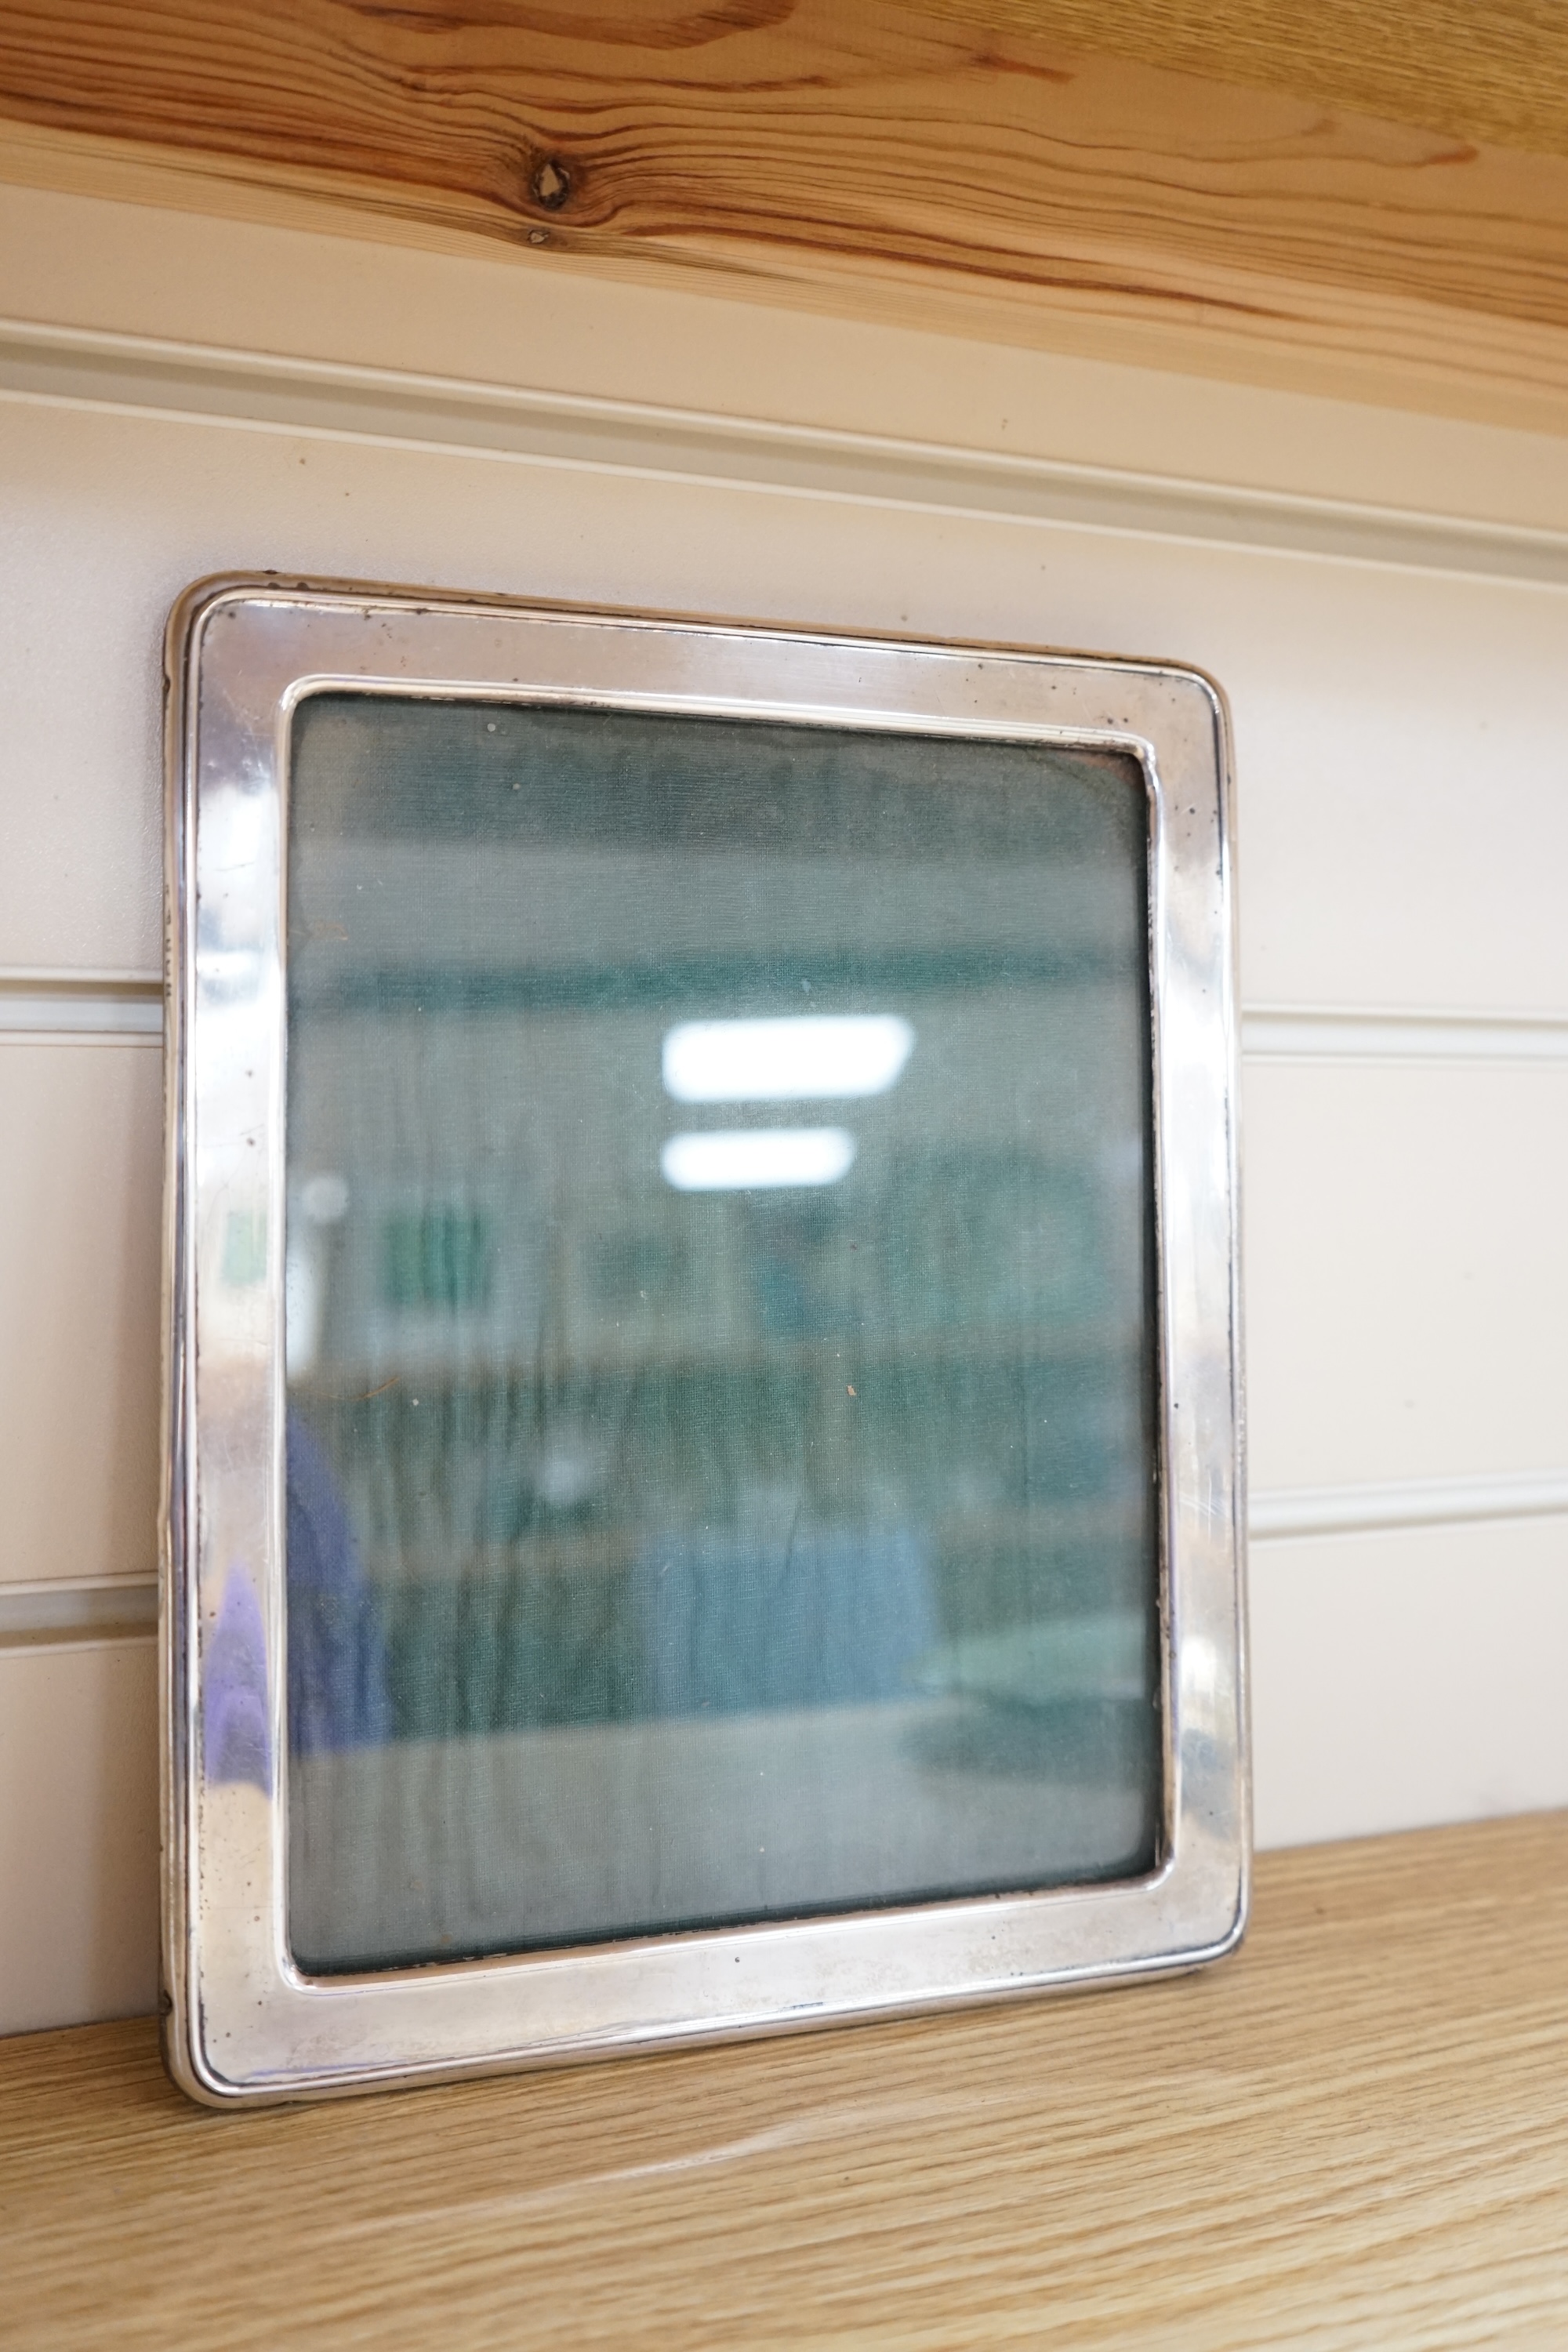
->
289, 1324, 1145, 1404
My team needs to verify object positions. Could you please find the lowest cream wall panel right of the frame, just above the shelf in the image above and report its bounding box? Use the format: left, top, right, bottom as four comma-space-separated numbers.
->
1250, 1517, 1568, 1846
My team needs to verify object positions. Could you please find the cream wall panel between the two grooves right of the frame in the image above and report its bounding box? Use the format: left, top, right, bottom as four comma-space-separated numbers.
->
1243, 1061, 1568, 1486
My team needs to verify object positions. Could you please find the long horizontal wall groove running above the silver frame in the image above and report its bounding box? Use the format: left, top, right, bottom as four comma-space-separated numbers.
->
0, 320, 1568, 588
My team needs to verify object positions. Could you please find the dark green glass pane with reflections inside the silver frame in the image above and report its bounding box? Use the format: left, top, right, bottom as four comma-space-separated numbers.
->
281, 696, 1161, 1971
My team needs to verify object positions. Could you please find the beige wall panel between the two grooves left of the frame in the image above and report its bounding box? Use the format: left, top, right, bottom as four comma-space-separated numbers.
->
0, 1037, 162, 1581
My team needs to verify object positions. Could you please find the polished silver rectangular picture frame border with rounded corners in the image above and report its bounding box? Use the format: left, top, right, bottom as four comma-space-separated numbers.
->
162, 579, 1250, 2105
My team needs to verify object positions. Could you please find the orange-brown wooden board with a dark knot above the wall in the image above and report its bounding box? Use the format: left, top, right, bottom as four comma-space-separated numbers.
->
0, 0, 1568, 430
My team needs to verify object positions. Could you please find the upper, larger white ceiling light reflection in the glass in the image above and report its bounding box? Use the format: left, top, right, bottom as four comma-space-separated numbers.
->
666, 1014, 914, 1105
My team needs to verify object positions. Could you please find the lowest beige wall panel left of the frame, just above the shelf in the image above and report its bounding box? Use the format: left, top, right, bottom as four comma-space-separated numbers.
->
0, 1642, 158, 2034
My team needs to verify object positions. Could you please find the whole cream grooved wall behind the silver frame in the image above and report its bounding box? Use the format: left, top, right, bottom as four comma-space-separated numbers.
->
0, 191, 1568, 2030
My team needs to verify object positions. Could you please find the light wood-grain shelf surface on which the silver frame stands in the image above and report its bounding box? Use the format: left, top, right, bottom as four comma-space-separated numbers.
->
0, 1816, 1568, 2352
